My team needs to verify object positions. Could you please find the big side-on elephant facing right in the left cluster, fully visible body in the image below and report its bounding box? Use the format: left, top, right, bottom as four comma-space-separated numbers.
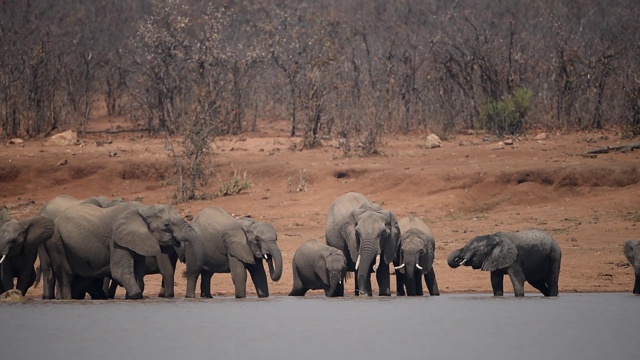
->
46, 202, 202, 299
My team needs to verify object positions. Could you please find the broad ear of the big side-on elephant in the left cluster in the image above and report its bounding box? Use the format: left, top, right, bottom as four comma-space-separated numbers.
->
113, 209, 161, 256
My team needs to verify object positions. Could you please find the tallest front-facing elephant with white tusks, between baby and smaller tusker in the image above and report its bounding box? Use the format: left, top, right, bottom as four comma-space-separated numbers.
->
325, 192, 400, 296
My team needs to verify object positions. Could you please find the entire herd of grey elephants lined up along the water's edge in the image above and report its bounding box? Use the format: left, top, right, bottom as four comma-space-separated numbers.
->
0, 192, 640, 299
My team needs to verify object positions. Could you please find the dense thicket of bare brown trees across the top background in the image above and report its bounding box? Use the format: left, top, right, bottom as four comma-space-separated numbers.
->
0, 0, 640, 149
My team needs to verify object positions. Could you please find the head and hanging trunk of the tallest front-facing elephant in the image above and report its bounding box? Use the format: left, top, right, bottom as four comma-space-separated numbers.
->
346, 204, 400, 293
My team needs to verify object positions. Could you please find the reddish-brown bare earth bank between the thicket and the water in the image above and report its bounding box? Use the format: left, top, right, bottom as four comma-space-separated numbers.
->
0, 122, 640, 299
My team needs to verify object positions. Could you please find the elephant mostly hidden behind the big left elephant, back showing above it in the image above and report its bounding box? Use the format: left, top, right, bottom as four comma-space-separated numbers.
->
38, 195, 123, 299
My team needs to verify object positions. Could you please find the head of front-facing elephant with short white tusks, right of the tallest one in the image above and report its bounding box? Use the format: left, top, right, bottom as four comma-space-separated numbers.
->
395, 228, 435, 295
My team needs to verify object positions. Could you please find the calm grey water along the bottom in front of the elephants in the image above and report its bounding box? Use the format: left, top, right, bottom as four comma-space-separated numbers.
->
0, 294, 640, 360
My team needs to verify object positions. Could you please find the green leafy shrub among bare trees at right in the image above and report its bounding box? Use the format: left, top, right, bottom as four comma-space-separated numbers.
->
480, 89, 533, 137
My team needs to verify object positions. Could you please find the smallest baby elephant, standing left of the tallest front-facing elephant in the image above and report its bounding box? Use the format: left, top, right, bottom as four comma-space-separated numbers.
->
289, 240, 347, 297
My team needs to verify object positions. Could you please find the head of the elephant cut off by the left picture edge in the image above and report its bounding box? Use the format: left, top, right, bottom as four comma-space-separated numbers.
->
0, 208, 54, 265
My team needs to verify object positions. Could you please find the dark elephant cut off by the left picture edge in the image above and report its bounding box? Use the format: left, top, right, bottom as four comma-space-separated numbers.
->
0, 207, 55, 296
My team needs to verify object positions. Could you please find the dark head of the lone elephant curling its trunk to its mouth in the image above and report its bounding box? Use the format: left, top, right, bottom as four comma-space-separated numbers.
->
447, 233, 518, 271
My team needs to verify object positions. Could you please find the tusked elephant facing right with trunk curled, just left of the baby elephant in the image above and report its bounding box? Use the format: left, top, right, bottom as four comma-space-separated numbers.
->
185, 206, 282, 298
